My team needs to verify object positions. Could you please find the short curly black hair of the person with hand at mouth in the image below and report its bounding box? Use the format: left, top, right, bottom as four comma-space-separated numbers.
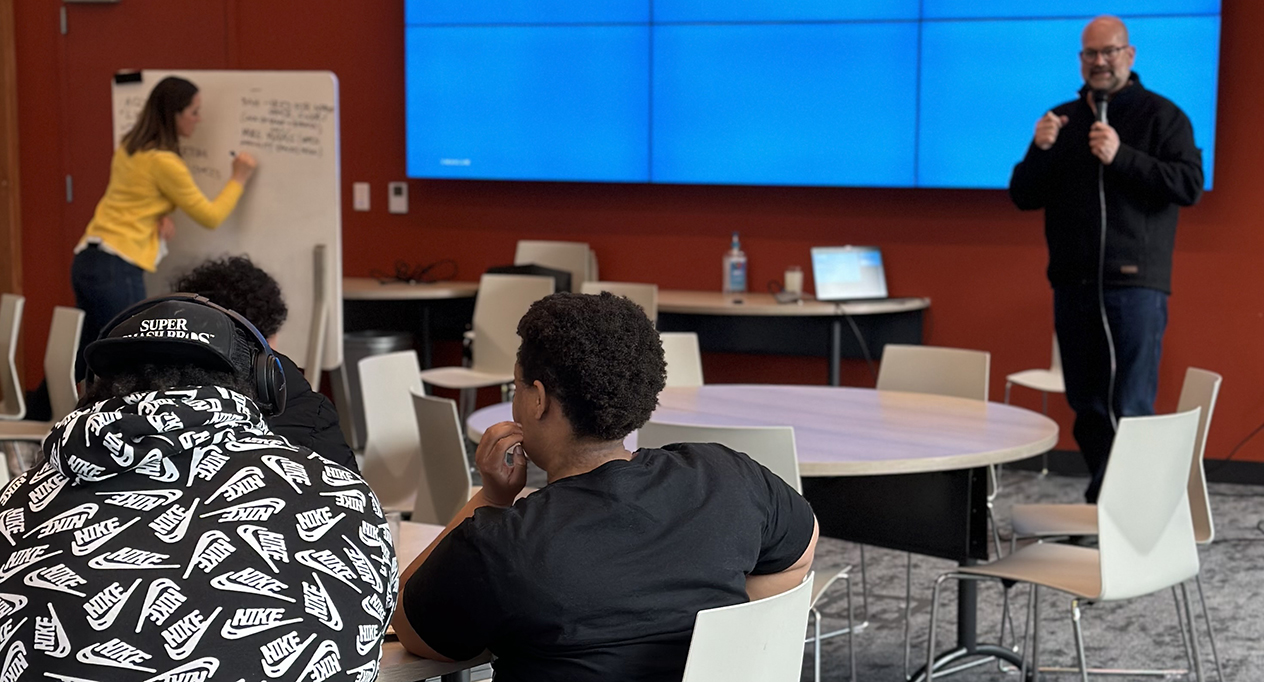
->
518, 292, 667, 441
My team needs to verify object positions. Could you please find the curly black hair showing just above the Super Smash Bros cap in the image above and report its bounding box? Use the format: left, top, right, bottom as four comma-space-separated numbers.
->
172, 255, 289, 338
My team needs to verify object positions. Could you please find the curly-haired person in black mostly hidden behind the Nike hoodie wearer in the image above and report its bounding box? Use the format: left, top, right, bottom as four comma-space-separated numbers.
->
172, 256, 360, 474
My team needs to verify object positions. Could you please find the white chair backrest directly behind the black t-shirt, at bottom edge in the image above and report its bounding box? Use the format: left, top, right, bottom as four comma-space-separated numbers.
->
681, 573, 814, 682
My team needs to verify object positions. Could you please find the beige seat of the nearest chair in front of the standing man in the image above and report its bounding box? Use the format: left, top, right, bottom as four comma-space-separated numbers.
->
958, 542, 1102, 599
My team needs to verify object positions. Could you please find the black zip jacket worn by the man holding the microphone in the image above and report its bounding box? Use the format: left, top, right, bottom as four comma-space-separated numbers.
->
1010, 72, 1202, 293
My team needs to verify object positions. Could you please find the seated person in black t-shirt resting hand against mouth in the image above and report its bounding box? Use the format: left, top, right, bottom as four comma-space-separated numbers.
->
393, 293, 817, 682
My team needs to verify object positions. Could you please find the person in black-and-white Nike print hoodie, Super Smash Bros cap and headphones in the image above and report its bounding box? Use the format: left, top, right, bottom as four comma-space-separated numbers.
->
0, 294, 398, 682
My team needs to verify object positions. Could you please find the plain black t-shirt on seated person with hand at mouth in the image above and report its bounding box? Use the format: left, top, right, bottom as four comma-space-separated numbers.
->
403, 443, 813, 682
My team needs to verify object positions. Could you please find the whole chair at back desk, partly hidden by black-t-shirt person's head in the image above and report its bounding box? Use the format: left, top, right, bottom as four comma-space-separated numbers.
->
419, 274, 554, 421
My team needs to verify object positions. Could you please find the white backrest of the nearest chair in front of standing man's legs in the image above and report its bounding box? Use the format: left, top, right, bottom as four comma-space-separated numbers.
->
1097, 408, 1201, 600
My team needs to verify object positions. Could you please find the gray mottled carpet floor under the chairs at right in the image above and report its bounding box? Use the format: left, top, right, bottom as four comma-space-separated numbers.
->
804, 470, 1264, 682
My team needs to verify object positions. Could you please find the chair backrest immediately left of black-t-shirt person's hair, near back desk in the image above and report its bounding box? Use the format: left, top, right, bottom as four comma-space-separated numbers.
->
471, 274, 554, 374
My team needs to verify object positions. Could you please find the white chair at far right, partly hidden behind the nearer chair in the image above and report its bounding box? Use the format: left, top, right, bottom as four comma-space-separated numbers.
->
1010, 368, 1225, 679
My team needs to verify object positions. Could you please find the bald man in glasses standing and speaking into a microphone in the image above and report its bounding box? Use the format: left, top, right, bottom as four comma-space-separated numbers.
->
1010, 16, 1203, 503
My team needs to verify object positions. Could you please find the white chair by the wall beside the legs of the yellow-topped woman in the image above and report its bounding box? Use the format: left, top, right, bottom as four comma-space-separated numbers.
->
0, 306, 83, 474
